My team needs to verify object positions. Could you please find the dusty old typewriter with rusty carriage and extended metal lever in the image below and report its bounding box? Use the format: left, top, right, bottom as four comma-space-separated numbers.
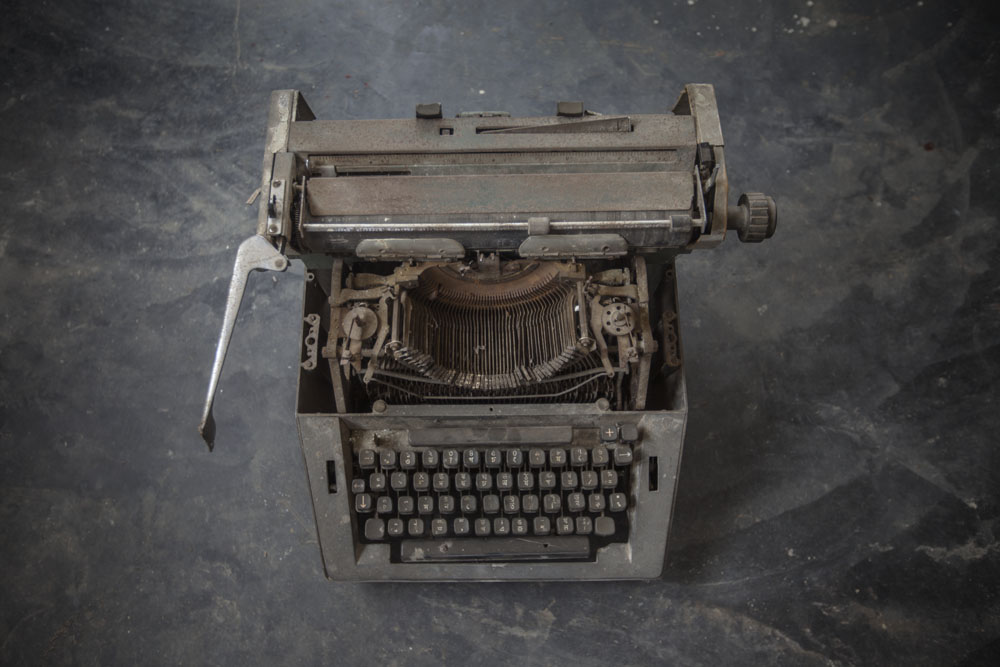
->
195, 84, 776, 580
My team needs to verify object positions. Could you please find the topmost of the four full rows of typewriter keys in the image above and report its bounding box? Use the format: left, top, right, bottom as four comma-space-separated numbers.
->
357, 445, 632, 470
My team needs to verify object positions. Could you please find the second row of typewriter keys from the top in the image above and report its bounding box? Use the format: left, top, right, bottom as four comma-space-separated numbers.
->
351, 468, 618, 493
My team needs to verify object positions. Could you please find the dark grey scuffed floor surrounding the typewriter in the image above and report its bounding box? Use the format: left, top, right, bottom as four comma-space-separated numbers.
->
0, 0, 1000, 665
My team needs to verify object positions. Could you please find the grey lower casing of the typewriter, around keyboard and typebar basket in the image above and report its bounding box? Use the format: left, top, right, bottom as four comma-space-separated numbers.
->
297, 253, 687, 581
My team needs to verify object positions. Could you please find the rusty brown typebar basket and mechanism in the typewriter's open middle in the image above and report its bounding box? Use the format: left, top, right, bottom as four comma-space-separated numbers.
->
323, 256, 656, 409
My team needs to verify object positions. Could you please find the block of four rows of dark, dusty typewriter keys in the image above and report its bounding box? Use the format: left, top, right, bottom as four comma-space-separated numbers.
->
351, 443, 633, 559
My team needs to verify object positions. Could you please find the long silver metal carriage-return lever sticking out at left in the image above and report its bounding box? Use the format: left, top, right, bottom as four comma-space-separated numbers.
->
198, 236, 288, 451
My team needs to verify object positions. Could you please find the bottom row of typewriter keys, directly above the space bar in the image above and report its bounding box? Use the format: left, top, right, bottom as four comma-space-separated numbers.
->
365, 516, 615, 542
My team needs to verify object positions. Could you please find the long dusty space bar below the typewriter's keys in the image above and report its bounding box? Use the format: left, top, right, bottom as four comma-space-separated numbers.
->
400, 536, 590, 563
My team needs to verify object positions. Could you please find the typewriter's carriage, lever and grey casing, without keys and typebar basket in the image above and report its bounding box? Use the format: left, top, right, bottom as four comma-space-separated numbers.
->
199, 84, 777, 581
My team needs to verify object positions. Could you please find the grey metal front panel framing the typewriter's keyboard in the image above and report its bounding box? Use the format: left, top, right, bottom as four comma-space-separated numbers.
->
298, 402, 687, 581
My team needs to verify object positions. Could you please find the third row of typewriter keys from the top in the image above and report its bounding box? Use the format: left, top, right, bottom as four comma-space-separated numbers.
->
354, 492, 628, 516
